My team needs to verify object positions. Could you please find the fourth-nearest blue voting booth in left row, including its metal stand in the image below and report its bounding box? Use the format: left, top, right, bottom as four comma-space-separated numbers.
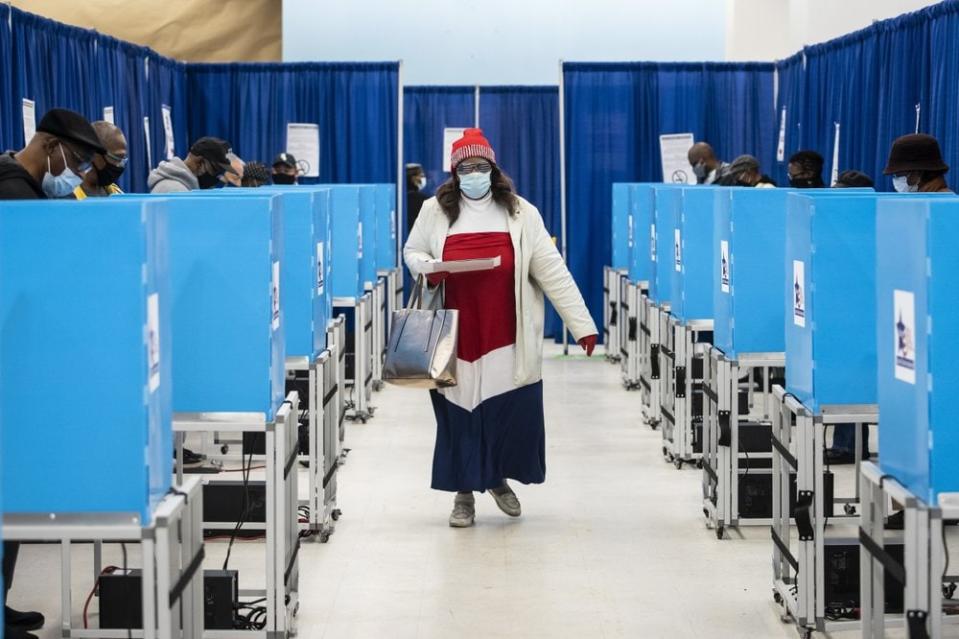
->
328, 184, 375, 422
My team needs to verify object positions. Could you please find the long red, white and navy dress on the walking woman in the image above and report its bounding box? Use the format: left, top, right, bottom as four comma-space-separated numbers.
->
431, 195, 546, 491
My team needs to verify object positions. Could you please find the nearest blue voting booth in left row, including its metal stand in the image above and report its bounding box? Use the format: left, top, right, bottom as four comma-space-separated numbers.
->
0, 200, 203, 638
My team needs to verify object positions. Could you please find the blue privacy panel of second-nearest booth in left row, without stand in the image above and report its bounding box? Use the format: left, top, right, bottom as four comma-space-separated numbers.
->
167, 191, 285, 419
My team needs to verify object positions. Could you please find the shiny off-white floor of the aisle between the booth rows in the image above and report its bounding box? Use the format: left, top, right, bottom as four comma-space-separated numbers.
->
12, 350, 952, 639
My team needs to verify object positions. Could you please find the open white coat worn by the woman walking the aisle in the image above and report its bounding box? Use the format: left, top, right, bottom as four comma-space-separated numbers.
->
403, 192, 598, 386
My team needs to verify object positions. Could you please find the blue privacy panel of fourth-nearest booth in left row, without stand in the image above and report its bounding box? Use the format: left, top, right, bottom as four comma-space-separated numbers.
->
329, 184, 363, 298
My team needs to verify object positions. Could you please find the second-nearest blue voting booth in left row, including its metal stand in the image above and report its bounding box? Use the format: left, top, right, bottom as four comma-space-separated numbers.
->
163, 191, 300, 632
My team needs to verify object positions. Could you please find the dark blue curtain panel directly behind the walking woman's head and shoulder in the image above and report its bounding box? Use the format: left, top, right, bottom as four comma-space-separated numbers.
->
479, 86, 562, 339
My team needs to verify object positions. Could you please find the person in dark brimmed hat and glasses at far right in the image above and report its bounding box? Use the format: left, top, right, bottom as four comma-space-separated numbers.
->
883, 133, 952, 193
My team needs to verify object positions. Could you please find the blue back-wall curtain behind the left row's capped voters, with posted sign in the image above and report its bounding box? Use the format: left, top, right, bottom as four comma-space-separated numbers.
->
187, 62, 399, 183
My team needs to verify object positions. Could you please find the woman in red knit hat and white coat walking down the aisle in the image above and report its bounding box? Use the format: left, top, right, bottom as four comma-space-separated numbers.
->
403, 129, 597, 528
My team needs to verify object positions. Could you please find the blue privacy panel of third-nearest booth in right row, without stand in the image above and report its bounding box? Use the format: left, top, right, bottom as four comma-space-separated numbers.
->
713, 188, 789, 358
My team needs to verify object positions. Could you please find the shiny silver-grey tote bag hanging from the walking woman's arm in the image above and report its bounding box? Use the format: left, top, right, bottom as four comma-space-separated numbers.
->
383, 275, 459, 388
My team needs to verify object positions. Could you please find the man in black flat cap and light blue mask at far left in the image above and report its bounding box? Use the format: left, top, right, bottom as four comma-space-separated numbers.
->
0, 109, 105, 200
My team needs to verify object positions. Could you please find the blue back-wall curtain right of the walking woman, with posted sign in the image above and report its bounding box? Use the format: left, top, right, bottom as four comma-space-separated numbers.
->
563, 62, 776, 332
